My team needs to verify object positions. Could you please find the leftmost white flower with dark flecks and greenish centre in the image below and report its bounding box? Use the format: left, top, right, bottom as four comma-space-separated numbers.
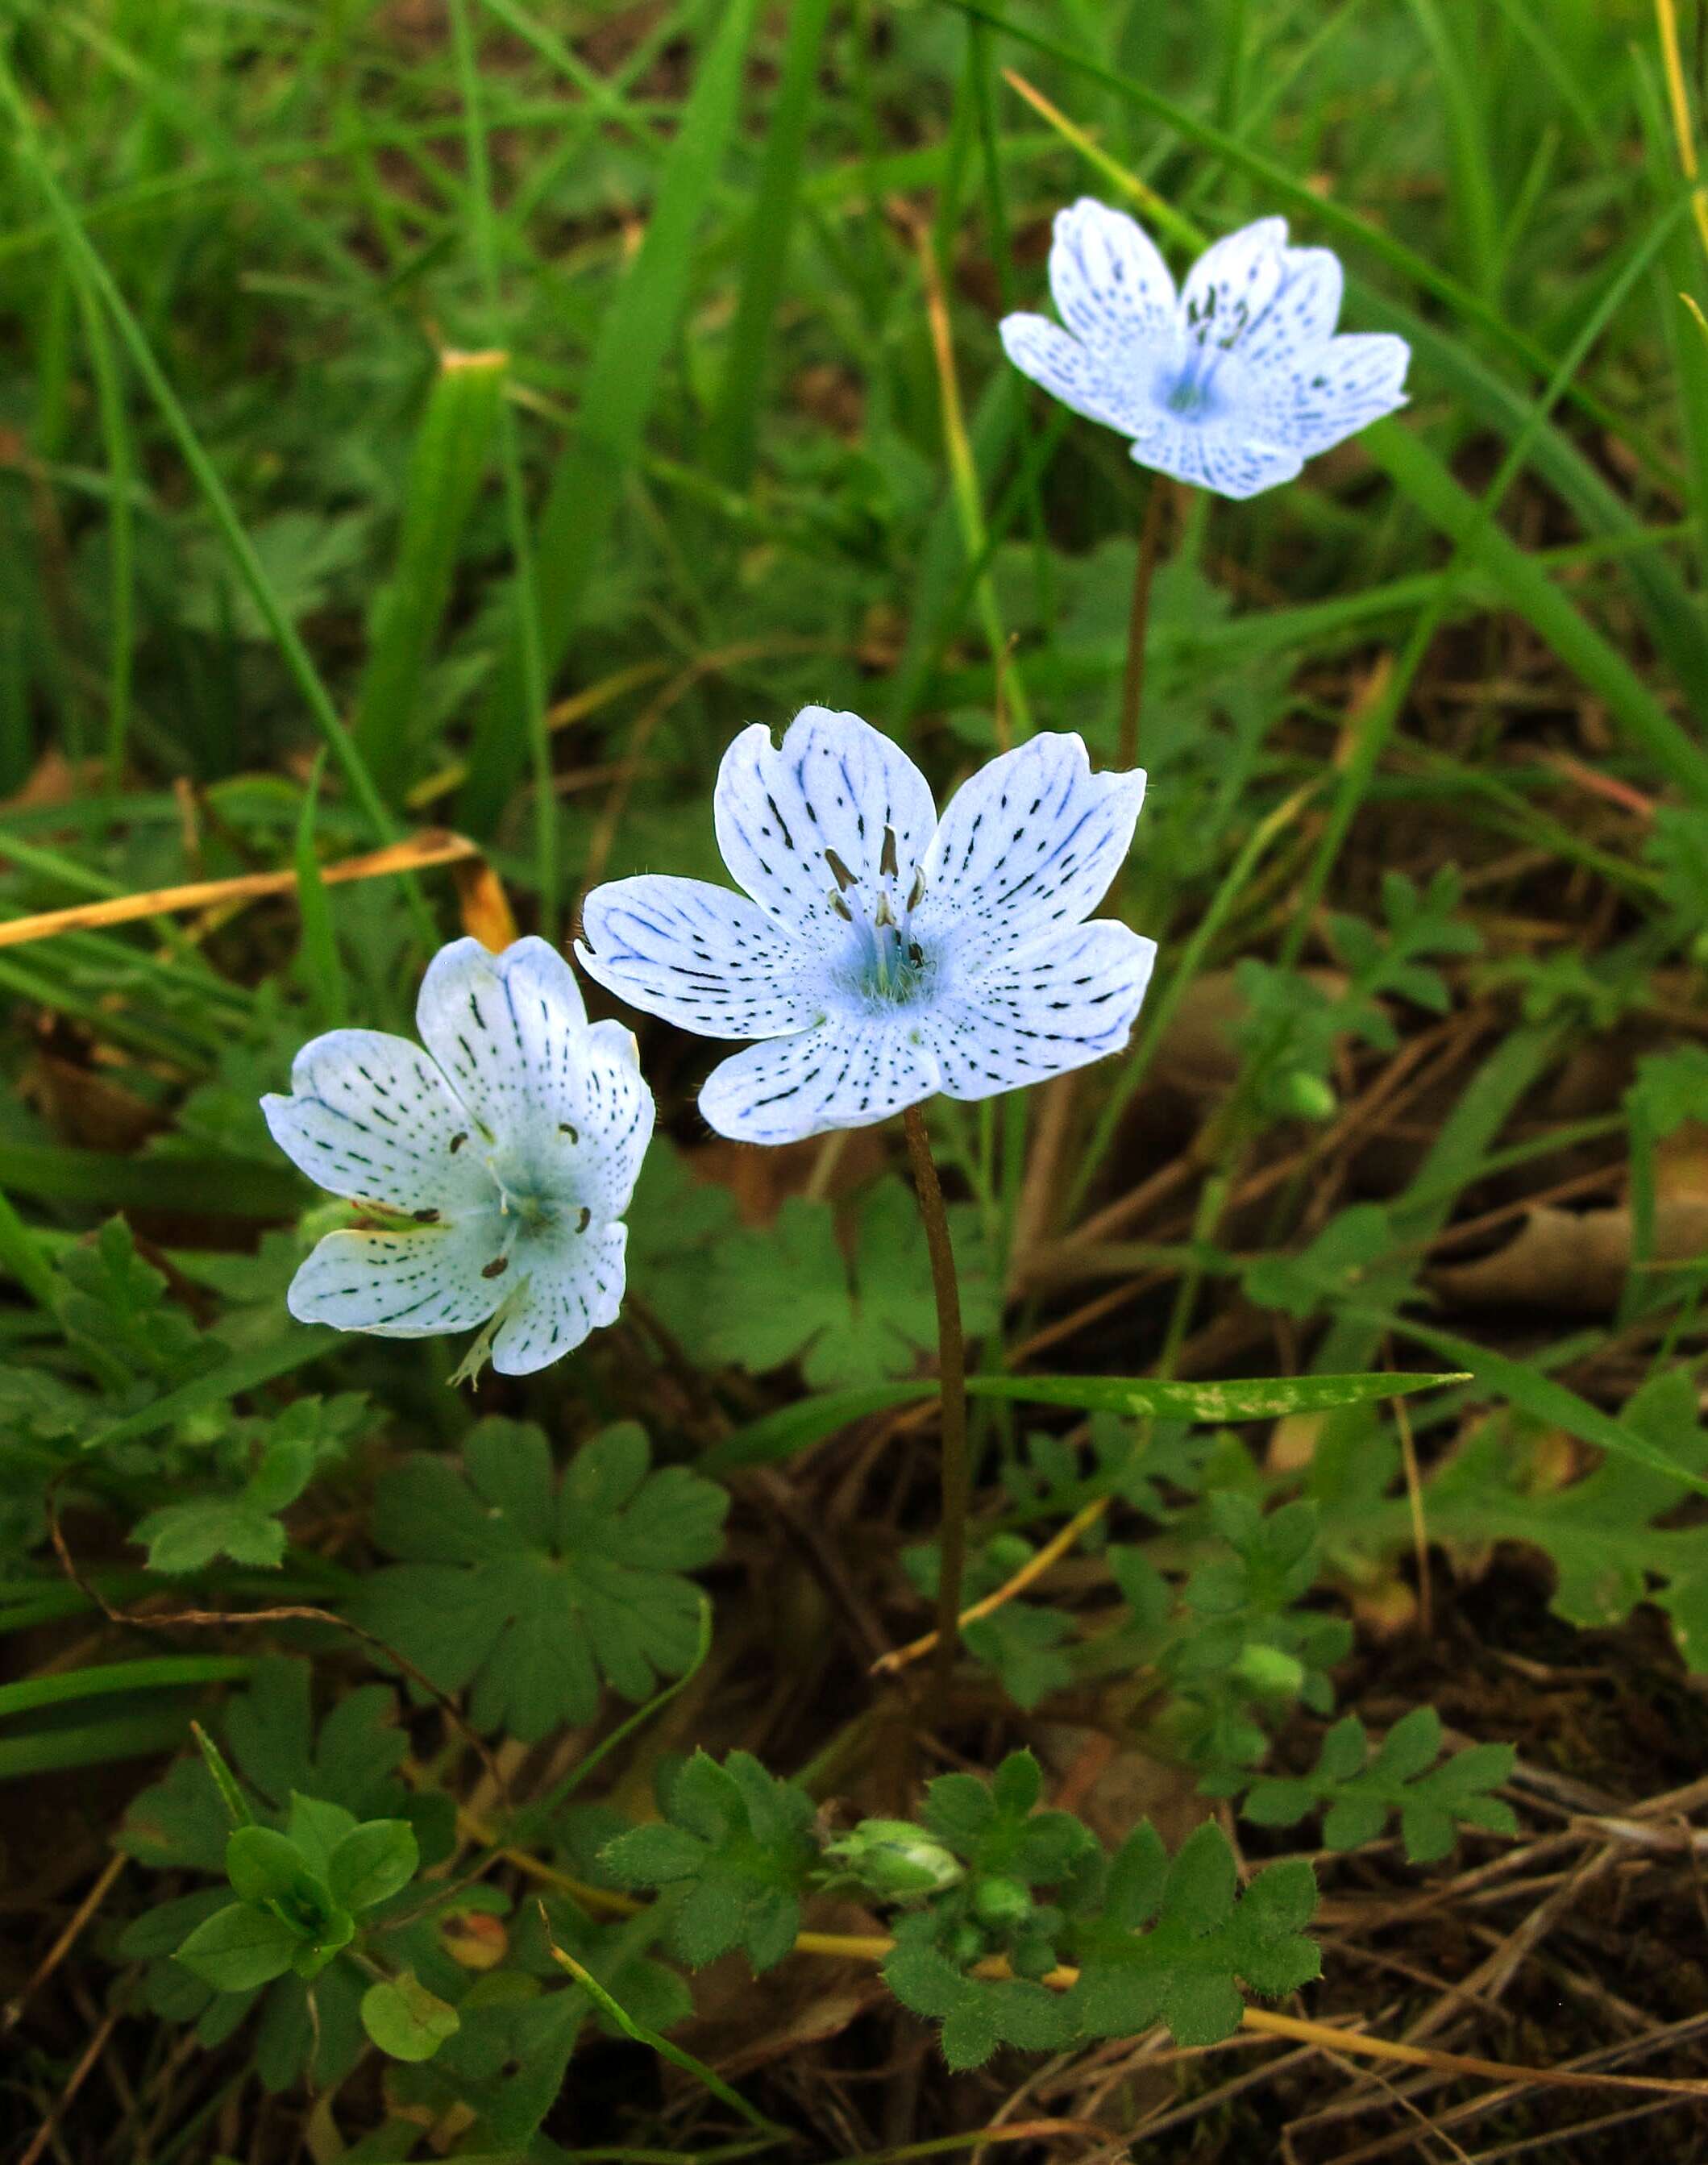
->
262, 940, 654, 1375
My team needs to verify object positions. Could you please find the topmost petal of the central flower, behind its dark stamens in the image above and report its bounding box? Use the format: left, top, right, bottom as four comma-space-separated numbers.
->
713, 706, 937, 948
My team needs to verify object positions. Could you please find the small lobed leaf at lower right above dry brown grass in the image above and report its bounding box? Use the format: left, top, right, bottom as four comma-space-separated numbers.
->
1240, 1706, 1518, 1864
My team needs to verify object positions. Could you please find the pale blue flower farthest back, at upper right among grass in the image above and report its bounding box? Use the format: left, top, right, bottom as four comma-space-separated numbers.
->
1002, 197, 1411, 498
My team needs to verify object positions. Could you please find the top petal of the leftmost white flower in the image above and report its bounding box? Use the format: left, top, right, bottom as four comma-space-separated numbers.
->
416, 940, 587, 1148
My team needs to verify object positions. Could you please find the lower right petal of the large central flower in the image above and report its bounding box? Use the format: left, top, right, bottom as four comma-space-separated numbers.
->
926, 920, 1156, 1098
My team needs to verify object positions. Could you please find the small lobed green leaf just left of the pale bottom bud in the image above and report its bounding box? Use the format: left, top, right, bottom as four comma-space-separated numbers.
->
602, 1752, 818, 1970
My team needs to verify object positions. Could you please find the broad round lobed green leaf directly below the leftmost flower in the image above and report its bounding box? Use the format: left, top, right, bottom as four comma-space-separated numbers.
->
353, 1420, 727, 1743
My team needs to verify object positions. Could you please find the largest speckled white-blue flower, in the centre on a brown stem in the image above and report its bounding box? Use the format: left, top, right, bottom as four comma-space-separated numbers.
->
576, 706, 1156, 1143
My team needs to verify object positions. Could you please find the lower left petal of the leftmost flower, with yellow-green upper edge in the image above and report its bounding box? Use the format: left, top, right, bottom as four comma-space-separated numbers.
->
286, 1210, 505, 1338
